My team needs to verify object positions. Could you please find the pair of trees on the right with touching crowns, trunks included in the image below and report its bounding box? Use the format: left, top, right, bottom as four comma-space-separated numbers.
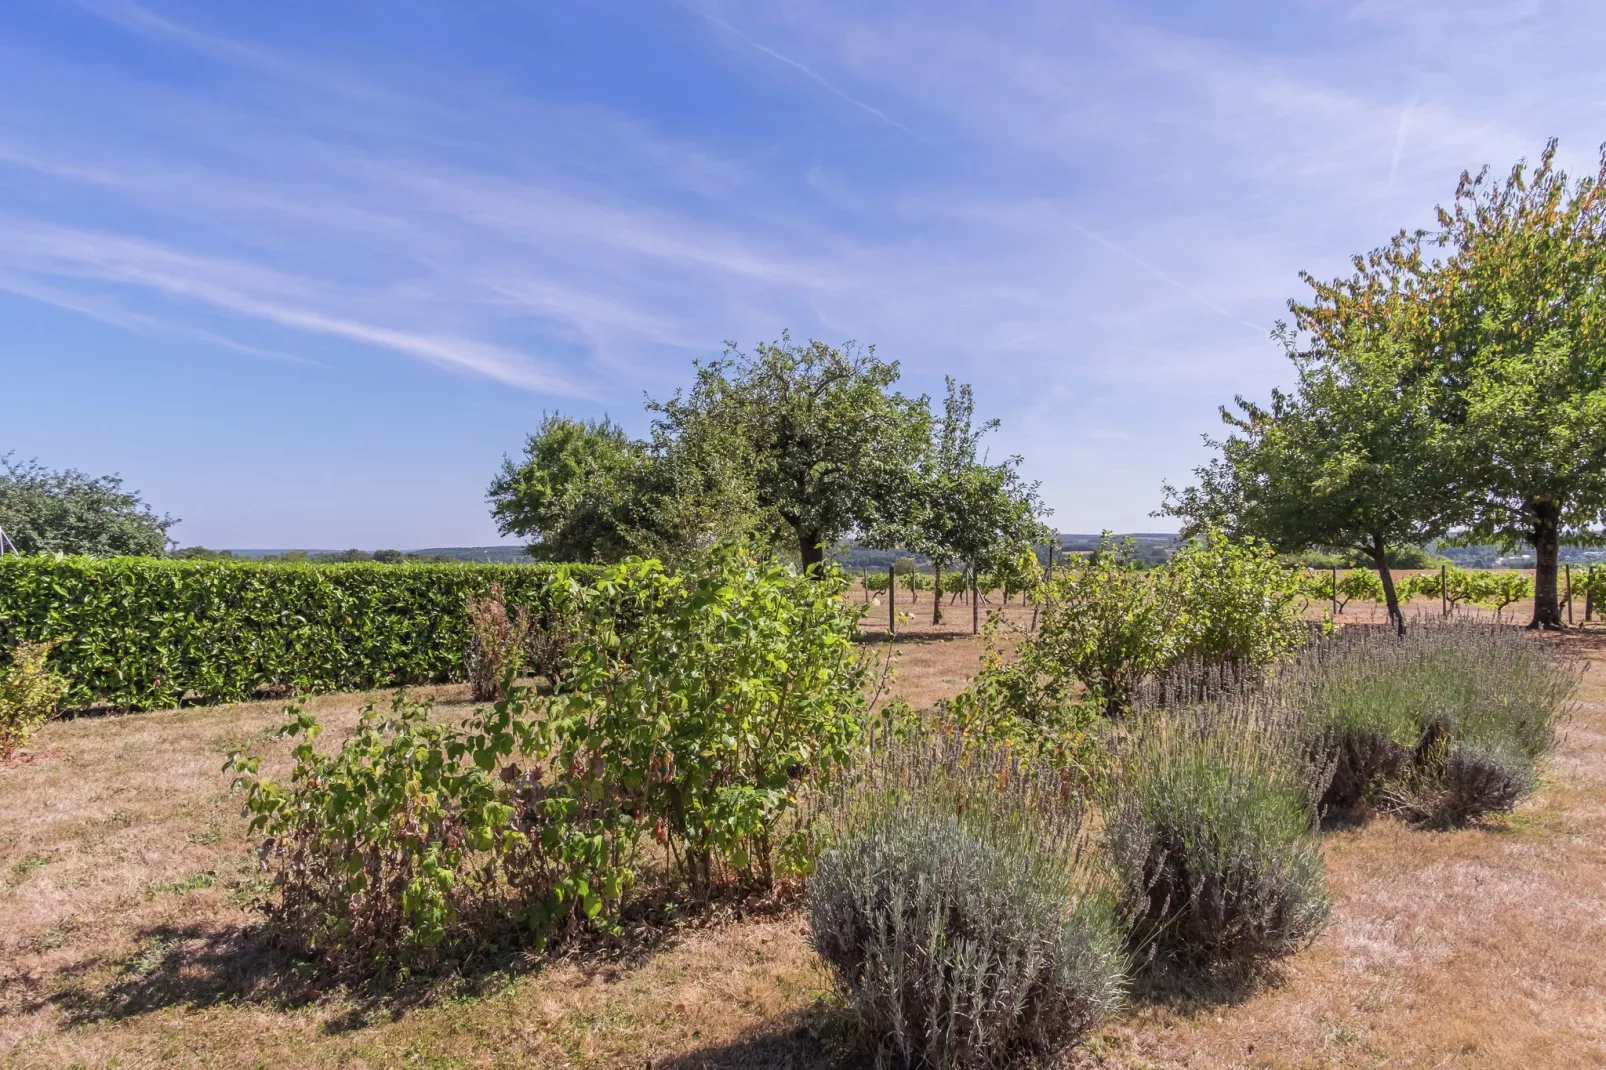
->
1164, 141, 1606, 628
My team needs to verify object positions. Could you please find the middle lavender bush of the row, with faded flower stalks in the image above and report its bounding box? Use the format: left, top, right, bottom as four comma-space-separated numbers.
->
1107, 692, 1330, 970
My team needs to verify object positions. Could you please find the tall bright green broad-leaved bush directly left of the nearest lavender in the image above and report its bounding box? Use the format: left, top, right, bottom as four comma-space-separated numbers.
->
549, 546, 867, 893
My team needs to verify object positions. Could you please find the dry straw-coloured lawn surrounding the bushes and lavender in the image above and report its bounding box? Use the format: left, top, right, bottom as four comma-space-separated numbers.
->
0, 594, 1606, 1070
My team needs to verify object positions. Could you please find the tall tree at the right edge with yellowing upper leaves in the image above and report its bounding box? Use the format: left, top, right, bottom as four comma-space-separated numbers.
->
1436, 140, 1606, 628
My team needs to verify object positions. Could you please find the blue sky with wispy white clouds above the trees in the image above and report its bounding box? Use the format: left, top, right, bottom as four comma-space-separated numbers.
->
0, 0, 1606, 548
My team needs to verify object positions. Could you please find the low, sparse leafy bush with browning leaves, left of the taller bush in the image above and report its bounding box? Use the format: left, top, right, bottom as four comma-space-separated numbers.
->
226, 689, 634, 972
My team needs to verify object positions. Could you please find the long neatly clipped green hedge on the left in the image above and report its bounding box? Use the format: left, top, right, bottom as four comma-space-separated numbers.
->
0, 554, 594, 710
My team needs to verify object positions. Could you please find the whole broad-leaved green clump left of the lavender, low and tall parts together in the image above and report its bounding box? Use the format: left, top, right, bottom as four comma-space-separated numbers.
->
228, 548, 866, 972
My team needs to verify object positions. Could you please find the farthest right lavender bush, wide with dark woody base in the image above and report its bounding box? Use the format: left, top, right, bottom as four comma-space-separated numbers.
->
1277, 622, 1579, 823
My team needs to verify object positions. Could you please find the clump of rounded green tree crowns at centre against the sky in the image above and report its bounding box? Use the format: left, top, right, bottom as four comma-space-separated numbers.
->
488, 334, 1044, 569
